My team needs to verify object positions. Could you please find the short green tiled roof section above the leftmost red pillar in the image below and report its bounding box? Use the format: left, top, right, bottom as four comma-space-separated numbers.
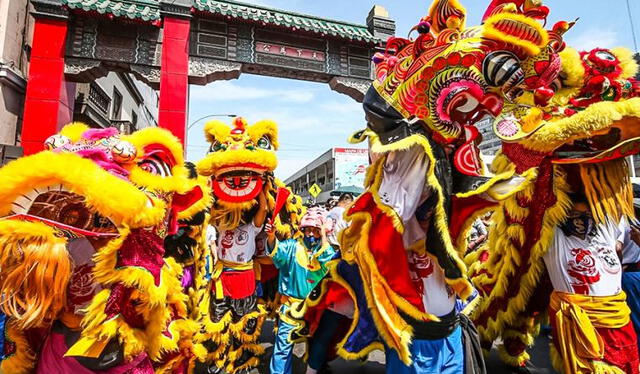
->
62, 0, 160, 21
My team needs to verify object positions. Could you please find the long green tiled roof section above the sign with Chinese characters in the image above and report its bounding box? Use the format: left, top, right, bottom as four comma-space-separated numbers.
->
193, 0, 378, 42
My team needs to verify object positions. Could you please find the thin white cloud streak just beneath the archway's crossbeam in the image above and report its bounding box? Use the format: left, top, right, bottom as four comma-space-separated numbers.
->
189, 81, 315, 104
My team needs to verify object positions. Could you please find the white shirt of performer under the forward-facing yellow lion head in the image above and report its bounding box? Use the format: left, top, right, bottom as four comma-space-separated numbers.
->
217, 222, 262, 264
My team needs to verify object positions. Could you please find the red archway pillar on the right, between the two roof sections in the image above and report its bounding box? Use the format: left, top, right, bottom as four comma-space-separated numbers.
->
158, 16, 190, 150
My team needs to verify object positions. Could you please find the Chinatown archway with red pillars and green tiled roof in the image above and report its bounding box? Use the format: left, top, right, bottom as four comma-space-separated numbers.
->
22, 0, 395, 154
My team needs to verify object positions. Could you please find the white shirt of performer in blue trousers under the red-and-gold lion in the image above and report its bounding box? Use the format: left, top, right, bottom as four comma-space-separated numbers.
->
378, 145, 456, 317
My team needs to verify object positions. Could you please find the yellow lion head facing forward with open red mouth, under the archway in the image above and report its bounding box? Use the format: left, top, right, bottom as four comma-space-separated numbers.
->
197, 117, 302, 237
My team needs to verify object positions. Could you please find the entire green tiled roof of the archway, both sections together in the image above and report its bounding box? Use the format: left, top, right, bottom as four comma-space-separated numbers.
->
63, 0, 380, 43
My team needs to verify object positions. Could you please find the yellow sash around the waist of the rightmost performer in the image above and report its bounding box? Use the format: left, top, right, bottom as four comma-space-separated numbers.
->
550, 292, 631, 374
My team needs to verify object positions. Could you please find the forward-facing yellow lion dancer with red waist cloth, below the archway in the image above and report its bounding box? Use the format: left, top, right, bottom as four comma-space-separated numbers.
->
197, 118, 302, 373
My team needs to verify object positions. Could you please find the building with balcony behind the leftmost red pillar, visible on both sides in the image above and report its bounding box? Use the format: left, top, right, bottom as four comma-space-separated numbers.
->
0, 0, 159, 164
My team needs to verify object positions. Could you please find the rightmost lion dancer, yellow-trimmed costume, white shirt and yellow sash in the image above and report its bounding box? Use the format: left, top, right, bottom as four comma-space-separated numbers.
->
468, 32, 640, 373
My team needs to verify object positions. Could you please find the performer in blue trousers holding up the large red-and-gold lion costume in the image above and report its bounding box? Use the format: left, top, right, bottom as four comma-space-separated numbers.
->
298, 1, 572, 373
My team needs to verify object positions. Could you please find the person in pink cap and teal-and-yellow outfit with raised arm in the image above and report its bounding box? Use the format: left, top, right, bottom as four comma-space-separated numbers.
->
265, 207, 336, 374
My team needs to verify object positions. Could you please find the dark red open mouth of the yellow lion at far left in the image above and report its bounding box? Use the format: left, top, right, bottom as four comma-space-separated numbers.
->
6, 184, 118, 238
